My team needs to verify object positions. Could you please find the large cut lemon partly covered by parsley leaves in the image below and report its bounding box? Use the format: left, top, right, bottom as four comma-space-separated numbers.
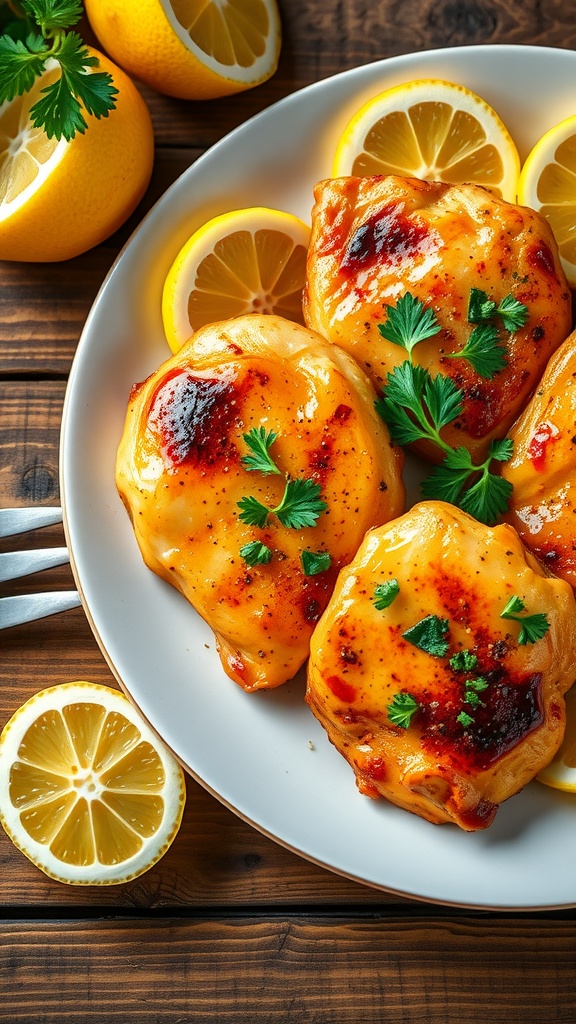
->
0, 50, 154, 261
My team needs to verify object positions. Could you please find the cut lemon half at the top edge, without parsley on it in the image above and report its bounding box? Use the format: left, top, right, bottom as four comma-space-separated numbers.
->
85, 0, 281, 99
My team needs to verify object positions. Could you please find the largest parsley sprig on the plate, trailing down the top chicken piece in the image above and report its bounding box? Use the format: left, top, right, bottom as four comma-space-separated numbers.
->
376, 292, 512, 525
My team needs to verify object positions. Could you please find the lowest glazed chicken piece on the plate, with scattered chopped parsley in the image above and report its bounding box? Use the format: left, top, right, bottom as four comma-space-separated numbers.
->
306, 502, 576, 831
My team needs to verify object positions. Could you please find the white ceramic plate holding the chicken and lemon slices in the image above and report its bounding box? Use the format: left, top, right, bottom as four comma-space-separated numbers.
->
61, 46, 576, 909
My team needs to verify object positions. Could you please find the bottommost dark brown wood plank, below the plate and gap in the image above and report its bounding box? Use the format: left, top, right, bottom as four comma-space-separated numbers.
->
0, 915, 576, 1024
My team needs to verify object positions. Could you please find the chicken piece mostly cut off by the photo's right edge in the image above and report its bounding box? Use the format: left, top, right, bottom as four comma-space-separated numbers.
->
502, 332, 576, 588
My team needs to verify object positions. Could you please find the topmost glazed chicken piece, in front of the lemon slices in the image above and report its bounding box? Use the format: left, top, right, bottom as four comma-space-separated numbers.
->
304, 176, 571, 460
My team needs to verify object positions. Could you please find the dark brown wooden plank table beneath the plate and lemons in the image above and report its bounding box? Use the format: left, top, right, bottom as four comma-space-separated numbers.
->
0, 0, 576, 1024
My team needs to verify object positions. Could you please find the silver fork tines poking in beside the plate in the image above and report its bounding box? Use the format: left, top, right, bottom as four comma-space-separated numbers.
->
0, 508, 81, 629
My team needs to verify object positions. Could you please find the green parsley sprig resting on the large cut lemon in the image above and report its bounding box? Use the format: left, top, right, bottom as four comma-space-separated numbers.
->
0, 0, 118, 141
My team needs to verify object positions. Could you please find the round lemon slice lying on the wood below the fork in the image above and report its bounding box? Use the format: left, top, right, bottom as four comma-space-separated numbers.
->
0, 682, 186, 885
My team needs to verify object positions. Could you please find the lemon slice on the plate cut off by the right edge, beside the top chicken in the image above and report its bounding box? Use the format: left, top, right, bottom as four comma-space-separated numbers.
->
518, 115, 576, 288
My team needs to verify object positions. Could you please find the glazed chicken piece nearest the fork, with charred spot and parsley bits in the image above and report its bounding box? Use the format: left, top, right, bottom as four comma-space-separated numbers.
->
116, 313, 404, 691
